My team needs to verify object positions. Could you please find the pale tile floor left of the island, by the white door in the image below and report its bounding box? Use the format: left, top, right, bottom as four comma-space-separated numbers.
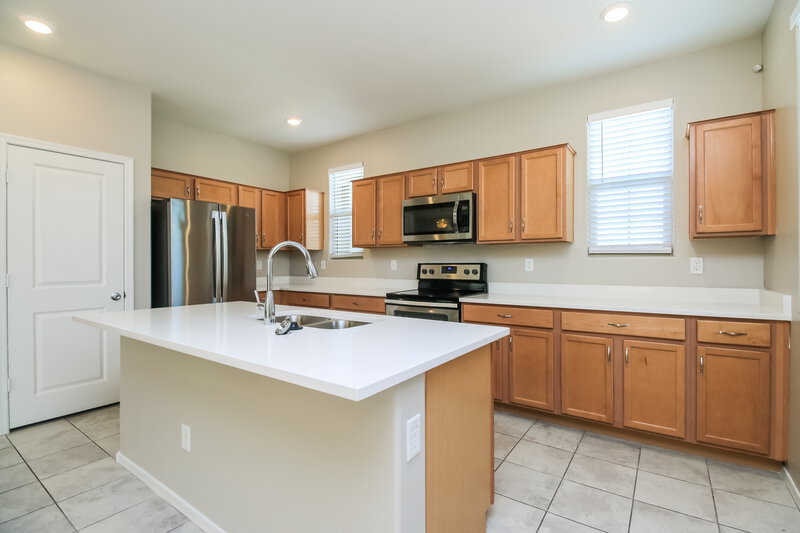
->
0, 405, 200, 533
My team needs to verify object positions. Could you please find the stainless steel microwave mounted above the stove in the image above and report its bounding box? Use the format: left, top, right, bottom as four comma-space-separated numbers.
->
403, 192, 475, 244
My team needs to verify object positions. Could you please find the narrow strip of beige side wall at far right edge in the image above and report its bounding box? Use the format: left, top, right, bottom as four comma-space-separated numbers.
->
762, 0, 800, 480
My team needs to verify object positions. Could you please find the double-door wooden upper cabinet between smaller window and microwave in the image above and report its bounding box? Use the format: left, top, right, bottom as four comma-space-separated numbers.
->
353, 174, 405, 248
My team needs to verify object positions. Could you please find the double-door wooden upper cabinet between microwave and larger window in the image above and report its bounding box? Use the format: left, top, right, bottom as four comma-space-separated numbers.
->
477, 144, 575, 243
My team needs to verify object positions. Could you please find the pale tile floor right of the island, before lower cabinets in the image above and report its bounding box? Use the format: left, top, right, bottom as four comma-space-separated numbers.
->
487, 411, 800, 533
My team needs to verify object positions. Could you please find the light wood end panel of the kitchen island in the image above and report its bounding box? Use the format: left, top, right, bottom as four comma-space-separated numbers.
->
425, 345, 494, 533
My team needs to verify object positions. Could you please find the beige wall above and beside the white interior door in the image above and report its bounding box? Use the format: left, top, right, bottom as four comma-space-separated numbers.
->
0, 45, 150, 307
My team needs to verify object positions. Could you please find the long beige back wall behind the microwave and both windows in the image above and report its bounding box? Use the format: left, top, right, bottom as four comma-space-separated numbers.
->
291, 37, 765, 288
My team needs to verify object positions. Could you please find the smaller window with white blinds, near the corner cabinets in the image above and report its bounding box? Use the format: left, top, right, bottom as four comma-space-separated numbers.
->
328, 163, 364, 258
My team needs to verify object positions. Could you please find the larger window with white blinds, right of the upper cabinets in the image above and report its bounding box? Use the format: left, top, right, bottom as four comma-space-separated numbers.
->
588, 99, 673, 254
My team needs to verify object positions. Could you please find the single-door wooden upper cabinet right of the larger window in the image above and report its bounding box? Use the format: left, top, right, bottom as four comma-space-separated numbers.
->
688, 110, 775, 238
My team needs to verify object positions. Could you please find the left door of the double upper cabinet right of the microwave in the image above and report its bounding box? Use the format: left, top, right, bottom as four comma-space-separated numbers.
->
478, 156, 517, 242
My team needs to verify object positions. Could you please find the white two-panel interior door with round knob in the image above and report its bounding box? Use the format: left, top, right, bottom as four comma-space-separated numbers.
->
6, 145, 125, 428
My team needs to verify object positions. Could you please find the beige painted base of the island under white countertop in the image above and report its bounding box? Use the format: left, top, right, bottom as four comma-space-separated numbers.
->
120, 338, 425, 533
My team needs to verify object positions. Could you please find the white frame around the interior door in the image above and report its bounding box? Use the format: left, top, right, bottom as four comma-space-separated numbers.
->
0, 133, 134, 435
